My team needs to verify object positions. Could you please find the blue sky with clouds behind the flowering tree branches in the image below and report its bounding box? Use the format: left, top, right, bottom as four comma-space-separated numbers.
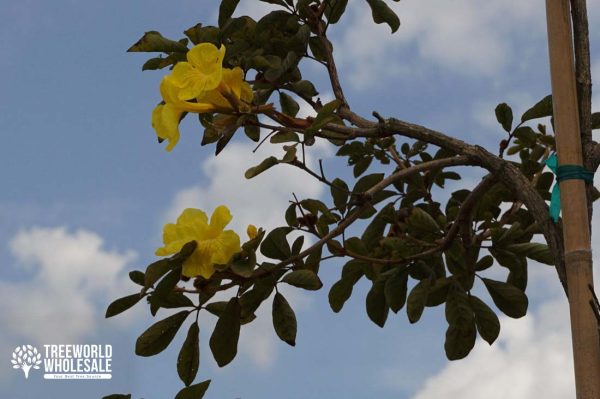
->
0, 0, 600, 399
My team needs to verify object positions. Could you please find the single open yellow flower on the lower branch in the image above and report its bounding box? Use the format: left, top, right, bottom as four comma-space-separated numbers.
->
156, 205, 241, 279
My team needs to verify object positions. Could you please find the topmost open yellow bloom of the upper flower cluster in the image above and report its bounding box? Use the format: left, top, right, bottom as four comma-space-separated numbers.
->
171, 43, 225, 100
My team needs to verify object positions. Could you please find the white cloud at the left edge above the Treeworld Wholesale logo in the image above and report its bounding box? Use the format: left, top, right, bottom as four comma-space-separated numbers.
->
0, 227, 136, 344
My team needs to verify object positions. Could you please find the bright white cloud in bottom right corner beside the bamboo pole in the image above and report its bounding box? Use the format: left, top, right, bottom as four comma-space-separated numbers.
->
413, 298, 575, 399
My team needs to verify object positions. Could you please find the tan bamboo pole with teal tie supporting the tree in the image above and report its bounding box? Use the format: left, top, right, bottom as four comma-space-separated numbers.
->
546, 0, 600, 399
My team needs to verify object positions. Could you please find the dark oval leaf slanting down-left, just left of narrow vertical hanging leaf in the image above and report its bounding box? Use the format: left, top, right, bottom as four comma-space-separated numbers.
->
135, 310, 190, 356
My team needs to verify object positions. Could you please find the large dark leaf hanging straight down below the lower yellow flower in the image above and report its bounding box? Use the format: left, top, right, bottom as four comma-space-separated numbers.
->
209, 297, 241, 367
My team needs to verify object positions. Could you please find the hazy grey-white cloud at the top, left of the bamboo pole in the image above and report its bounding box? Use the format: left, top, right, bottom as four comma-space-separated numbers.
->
334, 0, 545, 88
